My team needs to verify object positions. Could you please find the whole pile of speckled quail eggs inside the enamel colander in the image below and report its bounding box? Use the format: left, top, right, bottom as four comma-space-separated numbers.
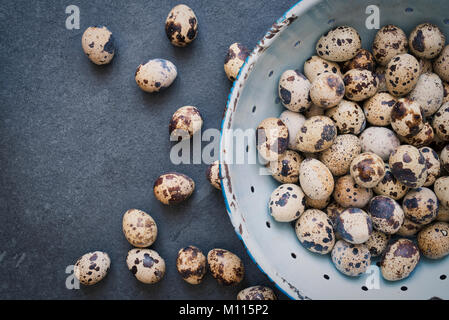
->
257, 23, 449, 281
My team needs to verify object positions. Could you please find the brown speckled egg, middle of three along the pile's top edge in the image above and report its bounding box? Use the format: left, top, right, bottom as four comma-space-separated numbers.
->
373, 24, 408, 66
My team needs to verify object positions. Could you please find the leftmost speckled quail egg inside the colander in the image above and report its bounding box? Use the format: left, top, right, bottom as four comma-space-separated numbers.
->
256, 118, 289, 161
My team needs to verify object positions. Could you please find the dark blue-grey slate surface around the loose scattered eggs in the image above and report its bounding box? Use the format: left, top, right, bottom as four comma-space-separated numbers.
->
0, 0, 295, 299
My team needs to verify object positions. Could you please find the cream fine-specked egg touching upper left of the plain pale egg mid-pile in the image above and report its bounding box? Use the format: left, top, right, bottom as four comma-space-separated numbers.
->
326, 99, 366, 134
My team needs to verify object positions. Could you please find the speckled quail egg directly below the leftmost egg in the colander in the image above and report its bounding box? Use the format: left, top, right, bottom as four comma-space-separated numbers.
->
267, 150, 303, 183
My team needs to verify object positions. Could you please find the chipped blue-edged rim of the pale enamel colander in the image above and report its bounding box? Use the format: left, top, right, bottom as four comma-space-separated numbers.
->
219, 0, 307, 300
